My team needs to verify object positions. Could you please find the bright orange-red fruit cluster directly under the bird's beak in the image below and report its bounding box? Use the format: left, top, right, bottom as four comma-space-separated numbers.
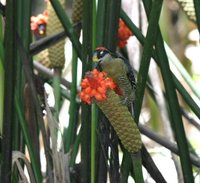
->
79, 69, 117, 104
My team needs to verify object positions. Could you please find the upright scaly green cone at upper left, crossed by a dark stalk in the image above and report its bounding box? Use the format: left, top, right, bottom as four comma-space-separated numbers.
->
47, 0, 65, 68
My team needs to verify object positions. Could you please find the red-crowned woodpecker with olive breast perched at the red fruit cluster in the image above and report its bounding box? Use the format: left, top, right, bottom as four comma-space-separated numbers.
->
93, 47, 136, 112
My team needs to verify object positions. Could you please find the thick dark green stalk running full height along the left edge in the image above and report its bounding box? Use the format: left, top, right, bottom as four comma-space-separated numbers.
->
0, 0, 16, 183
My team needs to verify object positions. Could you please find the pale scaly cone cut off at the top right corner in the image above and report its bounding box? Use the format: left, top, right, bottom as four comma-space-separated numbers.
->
177, 0, 196, 21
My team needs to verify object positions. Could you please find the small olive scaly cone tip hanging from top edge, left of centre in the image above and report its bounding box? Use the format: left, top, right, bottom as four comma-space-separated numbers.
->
72, 0, 83, 24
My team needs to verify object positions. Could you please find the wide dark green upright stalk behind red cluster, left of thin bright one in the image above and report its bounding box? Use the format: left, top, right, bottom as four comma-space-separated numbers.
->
81, 0, 93, 183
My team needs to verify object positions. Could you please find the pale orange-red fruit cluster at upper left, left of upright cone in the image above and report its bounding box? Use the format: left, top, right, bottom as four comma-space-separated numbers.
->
31, 11, 48, 32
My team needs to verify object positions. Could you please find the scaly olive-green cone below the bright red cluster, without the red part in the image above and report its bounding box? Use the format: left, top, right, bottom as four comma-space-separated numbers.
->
97, 90, 142, 153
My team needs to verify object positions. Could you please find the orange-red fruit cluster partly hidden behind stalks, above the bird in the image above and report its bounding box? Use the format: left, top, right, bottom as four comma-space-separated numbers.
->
118, 19, 133, 48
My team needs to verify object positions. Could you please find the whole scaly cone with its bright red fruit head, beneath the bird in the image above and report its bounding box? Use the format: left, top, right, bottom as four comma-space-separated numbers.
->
80, 69, 141, 153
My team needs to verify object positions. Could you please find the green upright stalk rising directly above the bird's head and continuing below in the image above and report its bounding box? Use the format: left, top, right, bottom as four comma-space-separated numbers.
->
93, 0, 109, 183
